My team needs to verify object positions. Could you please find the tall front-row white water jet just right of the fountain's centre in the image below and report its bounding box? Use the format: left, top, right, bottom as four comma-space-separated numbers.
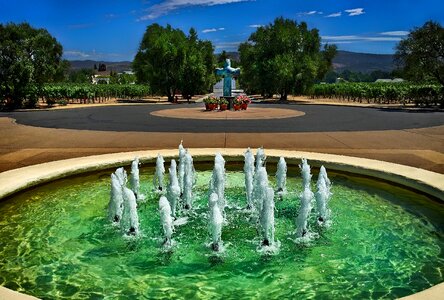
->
259, 187, 274, 246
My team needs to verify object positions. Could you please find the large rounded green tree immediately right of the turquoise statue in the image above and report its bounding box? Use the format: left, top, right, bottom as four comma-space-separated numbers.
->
239, 18, 336, 100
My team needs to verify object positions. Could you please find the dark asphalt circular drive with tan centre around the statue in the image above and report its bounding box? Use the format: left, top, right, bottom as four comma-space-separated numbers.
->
0, 103, 444, 133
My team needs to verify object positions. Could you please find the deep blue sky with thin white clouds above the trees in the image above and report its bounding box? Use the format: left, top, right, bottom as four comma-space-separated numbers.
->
0, 0, 444, 61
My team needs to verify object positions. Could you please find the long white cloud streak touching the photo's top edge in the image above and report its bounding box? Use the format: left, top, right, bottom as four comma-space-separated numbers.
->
138, 0, 254, 21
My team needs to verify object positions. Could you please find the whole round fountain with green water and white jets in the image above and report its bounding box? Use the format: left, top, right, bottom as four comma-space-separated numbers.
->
0, 149, 444, 299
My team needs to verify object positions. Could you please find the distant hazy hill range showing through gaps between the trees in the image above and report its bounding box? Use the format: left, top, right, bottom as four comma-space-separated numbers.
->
70, 50, 395, 73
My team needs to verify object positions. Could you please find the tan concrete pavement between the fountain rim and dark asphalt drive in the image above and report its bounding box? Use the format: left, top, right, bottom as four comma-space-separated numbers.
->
0, 111, 444, 174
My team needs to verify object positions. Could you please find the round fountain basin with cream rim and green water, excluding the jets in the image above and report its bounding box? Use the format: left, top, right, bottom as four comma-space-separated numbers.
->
0, 149, 444, 299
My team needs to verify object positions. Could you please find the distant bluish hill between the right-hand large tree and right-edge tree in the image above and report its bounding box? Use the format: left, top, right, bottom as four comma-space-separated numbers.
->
333, 51, 395, 73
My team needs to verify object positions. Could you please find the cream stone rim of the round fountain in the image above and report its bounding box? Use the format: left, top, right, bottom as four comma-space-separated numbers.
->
0, 148, 444, 299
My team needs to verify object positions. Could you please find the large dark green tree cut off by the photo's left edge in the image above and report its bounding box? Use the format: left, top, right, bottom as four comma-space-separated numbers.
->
0, 23, 69, 108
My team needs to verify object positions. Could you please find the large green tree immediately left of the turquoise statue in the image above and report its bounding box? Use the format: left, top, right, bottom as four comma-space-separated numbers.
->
133, 24, 215, 101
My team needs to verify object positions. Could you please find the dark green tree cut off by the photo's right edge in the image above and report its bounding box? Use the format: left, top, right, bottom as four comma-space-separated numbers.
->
395, 21, 444, 85
